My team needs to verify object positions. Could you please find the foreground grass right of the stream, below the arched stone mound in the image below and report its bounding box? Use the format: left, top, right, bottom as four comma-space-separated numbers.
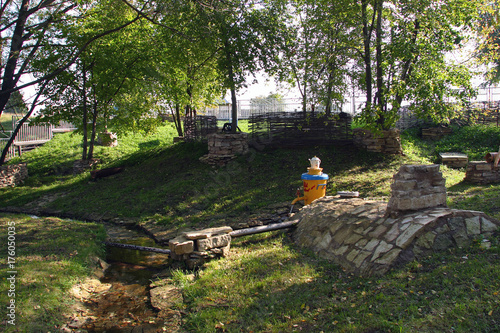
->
174, 232, 500, 332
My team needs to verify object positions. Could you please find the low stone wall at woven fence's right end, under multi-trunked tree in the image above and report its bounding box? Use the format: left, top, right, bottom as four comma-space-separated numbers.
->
353, 128, 403, 154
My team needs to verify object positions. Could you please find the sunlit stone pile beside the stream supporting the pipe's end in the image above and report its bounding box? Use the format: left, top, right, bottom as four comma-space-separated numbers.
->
168, 227, 233, 267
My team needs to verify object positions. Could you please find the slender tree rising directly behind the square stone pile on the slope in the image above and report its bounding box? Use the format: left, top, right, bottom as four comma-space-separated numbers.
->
197, 0, 286, 133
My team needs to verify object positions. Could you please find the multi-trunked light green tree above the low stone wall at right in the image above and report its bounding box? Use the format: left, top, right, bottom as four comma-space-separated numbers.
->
358, 0, 478, 130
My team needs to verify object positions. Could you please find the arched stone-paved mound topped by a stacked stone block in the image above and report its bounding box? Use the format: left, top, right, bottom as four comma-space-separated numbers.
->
292, 166, 500, 276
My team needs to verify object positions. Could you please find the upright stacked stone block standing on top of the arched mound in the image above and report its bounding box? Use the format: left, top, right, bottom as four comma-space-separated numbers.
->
387, 164, 446, 216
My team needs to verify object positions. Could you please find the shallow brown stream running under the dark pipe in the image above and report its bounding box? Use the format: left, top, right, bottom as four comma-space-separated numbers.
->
82, 225, 174, 333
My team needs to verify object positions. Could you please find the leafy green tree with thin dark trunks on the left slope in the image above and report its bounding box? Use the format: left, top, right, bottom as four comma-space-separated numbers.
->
35, 1, 152, 159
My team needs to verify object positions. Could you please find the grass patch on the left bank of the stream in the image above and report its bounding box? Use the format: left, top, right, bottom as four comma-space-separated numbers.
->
0, 214, 105, 332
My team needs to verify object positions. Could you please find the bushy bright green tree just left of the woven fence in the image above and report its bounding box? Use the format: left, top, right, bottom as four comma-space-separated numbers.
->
150, 1, 224, 136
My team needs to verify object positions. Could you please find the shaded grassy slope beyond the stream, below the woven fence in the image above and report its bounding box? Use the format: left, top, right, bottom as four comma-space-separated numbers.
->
0, 122, 480, 226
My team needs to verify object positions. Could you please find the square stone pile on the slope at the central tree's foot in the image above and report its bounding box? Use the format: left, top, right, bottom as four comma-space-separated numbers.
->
200, 133, 248, 166
